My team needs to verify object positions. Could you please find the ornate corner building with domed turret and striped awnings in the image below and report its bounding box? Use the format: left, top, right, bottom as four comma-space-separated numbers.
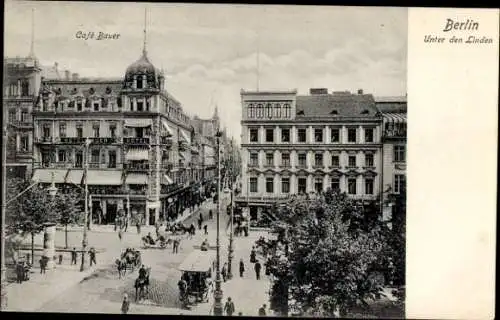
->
33, 43, 215, 224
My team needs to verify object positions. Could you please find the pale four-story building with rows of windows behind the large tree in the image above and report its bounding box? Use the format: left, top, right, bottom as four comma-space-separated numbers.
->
237, 88, 382, 219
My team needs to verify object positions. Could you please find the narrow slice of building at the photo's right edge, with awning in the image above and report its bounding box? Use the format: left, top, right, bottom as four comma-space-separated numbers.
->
375, 96, 407, 219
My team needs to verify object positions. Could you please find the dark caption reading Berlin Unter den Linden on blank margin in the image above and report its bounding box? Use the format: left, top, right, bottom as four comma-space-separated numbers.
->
424, 18, 493, 44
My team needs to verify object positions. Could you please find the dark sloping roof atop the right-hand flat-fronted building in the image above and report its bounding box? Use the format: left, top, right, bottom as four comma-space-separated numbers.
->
296, 93, 378, 117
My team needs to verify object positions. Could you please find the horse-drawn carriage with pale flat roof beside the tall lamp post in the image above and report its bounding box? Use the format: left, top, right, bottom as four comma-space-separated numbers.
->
178, 250, 215, 306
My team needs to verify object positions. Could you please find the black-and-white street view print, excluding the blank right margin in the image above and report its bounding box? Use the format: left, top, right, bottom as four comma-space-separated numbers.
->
1, 0, 408, 318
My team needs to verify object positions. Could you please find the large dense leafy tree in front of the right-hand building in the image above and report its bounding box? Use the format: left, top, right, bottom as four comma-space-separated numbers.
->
271, 190, 386, 316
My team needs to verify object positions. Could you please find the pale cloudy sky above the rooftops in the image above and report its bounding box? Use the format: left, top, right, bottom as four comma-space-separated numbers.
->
4, 0, 407, 141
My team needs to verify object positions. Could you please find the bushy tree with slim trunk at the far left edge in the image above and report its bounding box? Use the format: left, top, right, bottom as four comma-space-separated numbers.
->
5, 179, 59, 264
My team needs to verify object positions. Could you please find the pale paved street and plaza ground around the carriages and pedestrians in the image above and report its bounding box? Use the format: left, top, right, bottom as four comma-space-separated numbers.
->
4, 197, 269, 315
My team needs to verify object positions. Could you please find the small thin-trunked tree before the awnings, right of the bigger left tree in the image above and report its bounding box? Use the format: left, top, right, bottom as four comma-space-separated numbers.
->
55, 192, 82, 248
